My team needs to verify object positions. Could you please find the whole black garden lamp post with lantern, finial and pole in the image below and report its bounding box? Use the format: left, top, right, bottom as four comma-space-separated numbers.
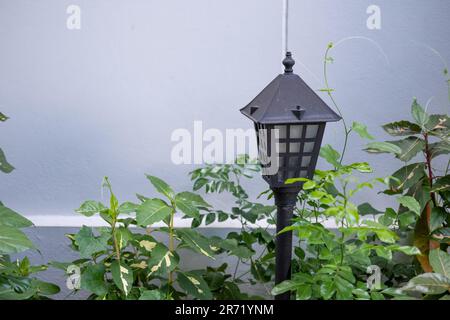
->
241, 52, 341, 300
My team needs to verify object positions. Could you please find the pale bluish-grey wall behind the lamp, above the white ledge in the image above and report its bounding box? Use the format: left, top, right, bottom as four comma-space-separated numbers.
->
0, 0, 450, 224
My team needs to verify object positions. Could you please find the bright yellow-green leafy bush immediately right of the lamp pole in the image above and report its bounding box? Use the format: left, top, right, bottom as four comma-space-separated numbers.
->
272, 159, 420, 300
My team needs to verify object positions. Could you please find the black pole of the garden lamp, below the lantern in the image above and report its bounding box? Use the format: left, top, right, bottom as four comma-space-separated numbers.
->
272, 187, 300, 300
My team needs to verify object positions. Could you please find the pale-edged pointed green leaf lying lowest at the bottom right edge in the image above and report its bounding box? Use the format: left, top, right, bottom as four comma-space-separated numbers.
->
402, 272, 450, 294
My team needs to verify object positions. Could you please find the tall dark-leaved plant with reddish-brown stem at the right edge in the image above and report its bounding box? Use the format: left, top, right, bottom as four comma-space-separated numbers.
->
366, 99, 450, 277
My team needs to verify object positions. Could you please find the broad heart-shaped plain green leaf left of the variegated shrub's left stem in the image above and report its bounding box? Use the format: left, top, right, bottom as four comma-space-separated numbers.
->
75, 226, 110, 258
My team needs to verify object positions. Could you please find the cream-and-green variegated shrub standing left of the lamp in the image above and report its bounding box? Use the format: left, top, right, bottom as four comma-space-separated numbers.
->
59, 175, 260, 300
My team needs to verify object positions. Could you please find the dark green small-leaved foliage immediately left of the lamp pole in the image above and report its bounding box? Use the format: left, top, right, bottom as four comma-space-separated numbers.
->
190, 155, 275, 299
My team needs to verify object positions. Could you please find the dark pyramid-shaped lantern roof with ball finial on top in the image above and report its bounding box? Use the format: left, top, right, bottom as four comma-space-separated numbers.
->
241, 52, 341, 124
